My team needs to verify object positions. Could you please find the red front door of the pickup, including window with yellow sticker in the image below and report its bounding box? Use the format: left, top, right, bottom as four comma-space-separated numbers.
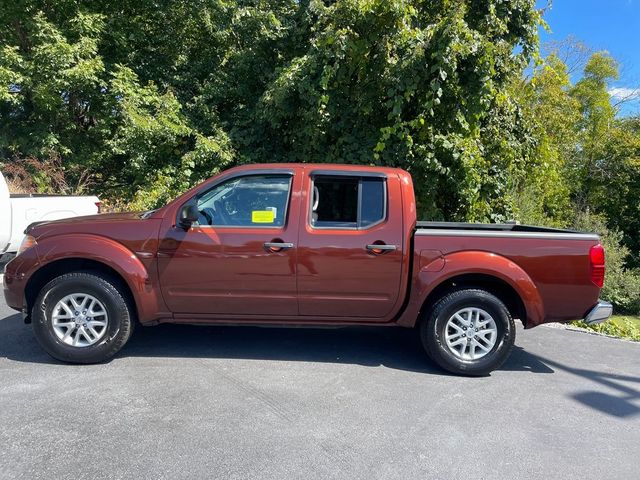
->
158, 170, 300, 317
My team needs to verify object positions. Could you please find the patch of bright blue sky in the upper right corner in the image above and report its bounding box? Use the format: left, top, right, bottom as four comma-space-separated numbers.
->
537, 0, 640, 115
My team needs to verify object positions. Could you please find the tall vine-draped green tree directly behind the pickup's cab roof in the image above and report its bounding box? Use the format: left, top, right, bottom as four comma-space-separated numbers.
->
247, 1, 539, 220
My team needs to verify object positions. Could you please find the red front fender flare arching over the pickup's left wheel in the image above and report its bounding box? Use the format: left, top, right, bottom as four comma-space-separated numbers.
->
27, 234, 163, 323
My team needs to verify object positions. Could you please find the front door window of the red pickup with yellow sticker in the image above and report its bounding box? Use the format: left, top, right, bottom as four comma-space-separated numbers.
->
197, 175, 291, 227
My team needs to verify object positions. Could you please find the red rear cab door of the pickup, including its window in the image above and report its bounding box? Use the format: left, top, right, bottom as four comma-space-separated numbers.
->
297, 169, 404, 322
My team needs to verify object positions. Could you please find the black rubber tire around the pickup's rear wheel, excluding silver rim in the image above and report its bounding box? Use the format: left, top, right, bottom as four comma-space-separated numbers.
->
420, 289, 516, 376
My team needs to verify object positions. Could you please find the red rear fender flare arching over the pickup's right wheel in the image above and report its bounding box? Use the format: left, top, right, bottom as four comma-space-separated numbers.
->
399, 250, 544, 327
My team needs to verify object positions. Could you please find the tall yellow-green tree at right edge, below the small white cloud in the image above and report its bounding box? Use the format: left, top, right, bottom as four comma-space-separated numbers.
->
569, 52, 640, 266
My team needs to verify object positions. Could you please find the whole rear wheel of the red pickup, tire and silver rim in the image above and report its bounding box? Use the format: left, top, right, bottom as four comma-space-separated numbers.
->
420, 289, 516, 376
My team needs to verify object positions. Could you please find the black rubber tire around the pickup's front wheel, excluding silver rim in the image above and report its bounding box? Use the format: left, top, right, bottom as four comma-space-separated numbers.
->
32, 272, 134, 363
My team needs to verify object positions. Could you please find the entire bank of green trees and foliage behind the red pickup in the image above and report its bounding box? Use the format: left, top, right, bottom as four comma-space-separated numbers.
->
0, 0, 640, 316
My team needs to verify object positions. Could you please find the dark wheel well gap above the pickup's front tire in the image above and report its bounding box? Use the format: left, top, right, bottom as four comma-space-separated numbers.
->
25, 258, 138, 323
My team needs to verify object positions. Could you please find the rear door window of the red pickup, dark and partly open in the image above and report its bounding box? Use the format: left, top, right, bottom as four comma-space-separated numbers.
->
311, 175, 387, 229
